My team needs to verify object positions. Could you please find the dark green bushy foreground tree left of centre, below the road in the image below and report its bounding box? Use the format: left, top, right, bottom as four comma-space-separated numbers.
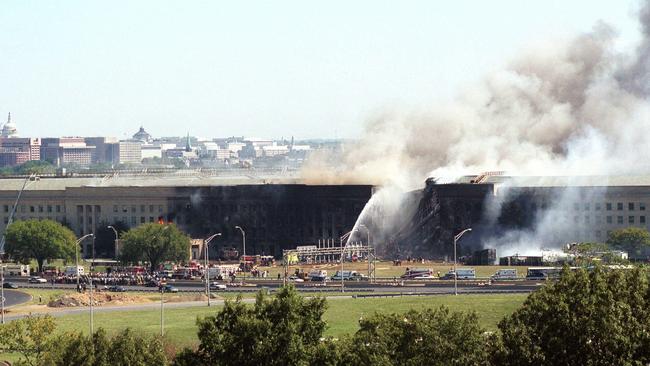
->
175, 286, 326, 366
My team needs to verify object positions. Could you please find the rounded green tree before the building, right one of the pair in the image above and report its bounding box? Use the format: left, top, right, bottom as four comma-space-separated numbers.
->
121, 223, 190, 271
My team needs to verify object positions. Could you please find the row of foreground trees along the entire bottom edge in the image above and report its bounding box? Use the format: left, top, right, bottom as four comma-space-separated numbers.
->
0, 267, 650, 366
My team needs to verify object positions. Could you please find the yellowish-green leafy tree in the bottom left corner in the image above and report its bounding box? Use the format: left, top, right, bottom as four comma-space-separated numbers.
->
0, 315, 56, 365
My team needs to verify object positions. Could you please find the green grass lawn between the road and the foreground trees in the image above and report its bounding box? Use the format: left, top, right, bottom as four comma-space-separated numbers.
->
49, 294, 527, 347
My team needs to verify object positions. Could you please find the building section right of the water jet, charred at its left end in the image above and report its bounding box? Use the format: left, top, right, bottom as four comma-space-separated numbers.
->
386, 173, 650, 259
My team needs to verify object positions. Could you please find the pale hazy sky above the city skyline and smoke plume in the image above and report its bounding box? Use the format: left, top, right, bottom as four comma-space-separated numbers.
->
0, 0, 639, 138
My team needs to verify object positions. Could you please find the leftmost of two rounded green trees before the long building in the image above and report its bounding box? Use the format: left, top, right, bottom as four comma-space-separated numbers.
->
5, 220, 78, 271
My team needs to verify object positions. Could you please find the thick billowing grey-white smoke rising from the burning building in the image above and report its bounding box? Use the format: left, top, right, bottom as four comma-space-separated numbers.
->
303, 0, 650, 256
